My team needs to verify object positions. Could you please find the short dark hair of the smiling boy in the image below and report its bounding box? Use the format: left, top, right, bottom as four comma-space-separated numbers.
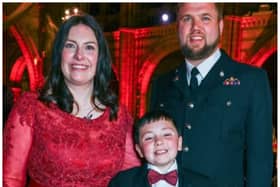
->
133, 110, 180, 144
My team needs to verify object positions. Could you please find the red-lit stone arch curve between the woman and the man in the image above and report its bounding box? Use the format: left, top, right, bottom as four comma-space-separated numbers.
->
137, 36, 179, 116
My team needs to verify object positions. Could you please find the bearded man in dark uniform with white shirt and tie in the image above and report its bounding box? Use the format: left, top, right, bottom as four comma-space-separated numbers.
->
150, 3, 272, 187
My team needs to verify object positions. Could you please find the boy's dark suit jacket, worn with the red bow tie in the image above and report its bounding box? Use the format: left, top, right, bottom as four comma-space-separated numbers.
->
109, 164, 187, 187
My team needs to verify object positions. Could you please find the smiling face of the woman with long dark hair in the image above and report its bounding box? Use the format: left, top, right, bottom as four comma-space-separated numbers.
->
61, 24, 99, 86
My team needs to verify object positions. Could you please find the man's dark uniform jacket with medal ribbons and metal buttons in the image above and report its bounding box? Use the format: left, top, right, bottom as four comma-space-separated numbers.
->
150, 51, 272, 187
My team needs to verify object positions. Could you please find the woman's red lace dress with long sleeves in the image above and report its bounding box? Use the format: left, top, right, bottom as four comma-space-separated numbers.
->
3, 93, 139, 187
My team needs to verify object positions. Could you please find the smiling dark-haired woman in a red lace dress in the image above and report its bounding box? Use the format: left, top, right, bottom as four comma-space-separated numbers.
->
3, 15, 139, 187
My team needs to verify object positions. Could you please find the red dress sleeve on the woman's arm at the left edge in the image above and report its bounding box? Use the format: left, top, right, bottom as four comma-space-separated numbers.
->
3, 93, 35, 187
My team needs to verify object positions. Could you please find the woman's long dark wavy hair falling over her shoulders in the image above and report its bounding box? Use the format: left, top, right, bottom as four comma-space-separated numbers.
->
39, 15, 118, 120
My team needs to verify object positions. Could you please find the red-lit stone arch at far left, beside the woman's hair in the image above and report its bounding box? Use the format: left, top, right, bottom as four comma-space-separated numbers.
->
3, 3, 44, 95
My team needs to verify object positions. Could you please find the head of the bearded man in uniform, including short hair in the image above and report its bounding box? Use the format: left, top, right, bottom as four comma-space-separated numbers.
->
178, 3, 223, 61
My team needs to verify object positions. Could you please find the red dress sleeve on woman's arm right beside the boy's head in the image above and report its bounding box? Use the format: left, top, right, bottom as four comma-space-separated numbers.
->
122, 108, 141, 170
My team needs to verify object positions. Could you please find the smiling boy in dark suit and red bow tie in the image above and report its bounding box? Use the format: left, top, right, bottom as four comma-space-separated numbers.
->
109, 111, 183, 187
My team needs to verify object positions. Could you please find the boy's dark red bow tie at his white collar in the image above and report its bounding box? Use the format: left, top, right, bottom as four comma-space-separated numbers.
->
148, 170, 178, 185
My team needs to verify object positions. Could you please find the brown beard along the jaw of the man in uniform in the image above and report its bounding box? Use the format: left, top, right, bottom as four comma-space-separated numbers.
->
181, 37, 220, 60
